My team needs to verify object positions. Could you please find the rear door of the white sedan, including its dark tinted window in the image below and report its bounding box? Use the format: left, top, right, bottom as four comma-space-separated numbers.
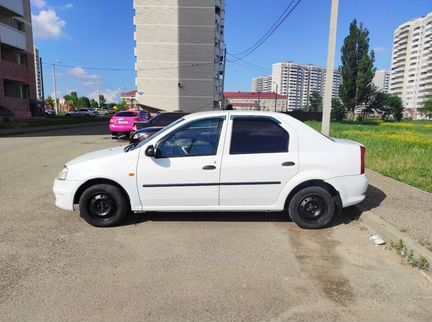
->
220, 115, 298, 207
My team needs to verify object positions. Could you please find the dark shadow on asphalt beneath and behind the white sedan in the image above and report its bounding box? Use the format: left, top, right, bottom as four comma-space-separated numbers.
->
122, 185, 386, 228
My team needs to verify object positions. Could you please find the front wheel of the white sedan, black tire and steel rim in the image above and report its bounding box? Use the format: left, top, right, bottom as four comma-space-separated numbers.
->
79, 184, 130, 227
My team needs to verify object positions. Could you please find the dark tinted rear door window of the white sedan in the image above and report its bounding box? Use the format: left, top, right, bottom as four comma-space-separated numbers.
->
230, 117, 289, 154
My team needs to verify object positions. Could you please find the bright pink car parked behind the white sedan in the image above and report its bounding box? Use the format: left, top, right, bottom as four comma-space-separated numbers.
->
109, 110, 151, 137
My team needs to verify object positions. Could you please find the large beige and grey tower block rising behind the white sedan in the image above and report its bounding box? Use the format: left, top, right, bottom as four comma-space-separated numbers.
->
134, 0, 225, 112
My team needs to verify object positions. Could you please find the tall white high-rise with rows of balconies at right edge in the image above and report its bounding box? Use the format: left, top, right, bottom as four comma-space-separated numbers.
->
390, 12, 432, 118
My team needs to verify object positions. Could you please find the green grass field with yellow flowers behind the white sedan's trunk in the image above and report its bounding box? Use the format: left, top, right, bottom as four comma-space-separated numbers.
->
307, 121, 432, 192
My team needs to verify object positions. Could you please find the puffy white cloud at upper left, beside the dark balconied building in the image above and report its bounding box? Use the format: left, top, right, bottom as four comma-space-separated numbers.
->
32, 9, 66, 40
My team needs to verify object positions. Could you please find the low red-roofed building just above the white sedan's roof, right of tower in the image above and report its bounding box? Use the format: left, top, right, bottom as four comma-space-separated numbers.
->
224, 92, 287, 112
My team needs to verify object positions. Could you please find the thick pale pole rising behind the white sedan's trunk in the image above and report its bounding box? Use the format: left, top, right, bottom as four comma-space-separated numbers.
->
321, 0, 339, 136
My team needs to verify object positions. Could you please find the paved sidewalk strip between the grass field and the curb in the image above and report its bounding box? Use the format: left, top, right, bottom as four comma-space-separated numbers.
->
360, 170, 432, 251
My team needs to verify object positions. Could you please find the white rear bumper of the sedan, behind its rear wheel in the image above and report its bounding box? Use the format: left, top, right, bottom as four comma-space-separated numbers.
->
326, 174, 368, 207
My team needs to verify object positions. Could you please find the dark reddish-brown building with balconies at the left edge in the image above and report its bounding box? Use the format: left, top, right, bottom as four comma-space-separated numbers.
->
0, 0, 36, 118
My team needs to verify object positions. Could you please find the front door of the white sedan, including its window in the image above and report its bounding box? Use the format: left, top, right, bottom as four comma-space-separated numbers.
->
138, 116, 226, 210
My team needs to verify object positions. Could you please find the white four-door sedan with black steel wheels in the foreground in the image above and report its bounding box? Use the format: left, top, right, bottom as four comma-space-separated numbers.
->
54, 111, 368, 228
